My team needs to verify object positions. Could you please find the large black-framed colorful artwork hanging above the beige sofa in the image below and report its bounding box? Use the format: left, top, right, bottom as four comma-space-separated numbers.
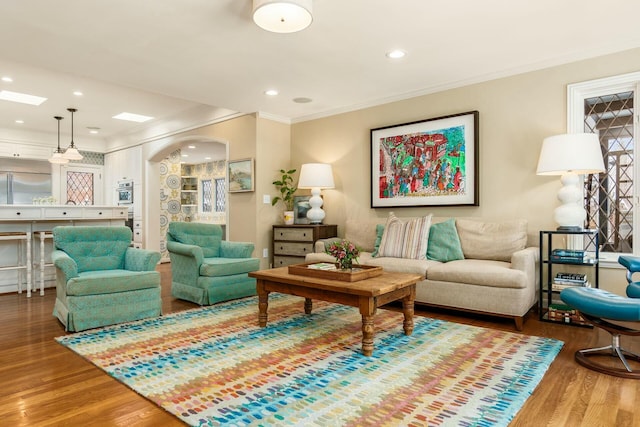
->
371, 111, 479, 208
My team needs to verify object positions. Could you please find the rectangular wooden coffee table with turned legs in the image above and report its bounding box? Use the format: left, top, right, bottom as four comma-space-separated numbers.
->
249, 267, 422, 356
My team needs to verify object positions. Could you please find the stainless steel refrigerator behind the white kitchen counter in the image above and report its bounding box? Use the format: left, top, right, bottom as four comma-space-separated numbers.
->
0, 158, 51, 205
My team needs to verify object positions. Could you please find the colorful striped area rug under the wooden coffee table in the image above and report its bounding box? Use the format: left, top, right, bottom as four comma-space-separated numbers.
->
57, 294, 562, 426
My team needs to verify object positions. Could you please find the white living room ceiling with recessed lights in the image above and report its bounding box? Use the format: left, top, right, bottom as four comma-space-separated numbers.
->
0, 0, 640, 159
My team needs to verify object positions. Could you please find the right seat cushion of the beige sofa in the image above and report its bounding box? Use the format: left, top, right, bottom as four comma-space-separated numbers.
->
427, 259, 527, 288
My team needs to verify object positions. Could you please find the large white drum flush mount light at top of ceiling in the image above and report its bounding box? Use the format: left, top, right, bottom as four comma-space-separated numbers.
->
253, 0, 313, 33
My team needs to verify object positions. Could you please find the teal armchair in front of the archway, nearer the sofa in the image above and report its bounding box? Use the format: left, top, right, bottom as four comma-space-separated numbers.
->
167, 222, 260, 305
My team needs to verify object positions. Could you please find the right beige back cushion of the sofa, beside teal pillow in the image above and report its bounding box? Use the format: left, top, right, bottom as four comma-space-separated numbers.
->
456, 219, 527, 261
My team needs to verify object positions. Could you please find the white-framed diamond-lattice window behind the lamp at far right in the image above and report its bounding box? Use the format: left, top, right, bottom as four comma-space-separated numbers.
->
567, 73, 640, 261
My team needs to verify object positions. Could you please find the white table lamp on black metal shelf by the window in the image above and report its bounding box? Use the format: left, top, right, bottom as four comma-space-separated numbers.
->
536, 133, 605, 231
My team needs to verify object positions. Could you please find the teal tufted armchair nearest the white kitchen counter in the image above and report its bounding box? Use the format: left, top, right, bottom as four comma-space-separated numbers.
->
51, 226, 162, 331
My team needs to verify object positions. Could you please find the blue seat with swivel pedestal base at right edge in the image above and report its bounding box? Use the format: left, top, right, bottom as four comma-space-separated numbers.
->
560, 256, 640, 379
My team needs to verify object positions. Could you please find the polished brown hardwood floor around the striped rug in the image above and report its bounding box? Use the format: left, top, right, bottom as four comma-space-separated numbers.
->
0, 264, 640, 427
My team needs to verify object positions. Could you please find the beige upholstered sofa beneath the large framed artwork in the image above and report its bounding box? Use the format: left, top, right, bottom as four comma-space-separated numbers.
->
306, 217, 539, 330
